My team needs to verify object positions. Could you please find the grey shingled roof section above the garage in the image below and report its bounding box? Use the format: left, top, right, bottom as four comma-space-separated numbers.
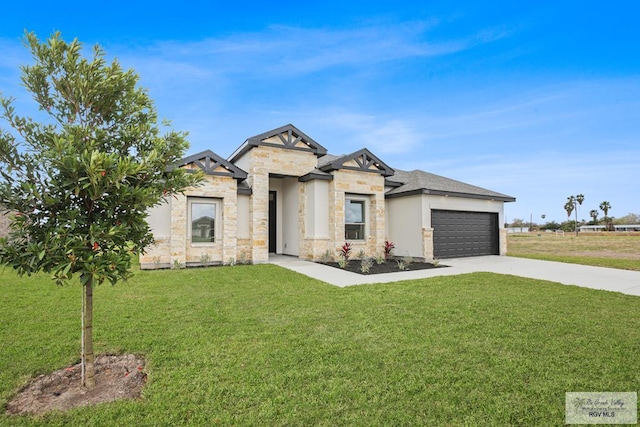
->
386, 170, 516, 202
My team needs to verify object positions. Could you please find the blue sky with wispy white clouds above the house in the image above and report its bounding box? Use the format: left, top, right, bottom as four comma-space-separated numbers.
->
0, 0, 640, 222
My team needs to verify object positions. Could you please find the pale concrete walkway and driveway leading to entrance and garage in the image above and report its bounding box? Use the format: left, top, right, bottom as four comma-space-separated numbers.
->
269, 254, 640, 296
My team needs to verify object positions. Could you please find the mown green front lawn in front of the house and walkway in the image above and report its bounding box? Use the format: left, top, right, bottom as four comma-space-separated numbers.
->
0, 265, 640, 426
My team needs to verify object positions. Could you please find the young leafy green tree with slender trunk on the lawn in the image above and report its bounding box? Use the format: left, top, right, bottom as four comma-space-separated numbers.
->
0, 33, 201, 388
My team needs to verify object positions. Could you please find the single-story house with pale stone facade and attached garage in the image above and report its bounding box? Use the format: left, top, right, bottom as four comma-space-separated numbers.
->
140, 124, 515, 268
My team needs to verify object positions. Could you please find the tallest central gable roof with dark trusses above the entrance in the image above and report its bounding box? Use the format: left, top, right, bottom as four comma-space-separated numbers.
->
229, 124, 327, 162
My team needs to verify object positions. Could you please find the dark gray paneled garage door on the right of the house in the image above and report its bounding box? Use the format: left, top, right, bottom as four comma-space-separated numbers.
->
431, 210, 500, 258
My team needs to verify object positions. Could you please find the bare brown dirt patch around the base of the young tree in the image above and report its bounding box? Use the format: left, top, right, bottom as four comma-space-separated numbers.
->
7, 354, 147, 415
